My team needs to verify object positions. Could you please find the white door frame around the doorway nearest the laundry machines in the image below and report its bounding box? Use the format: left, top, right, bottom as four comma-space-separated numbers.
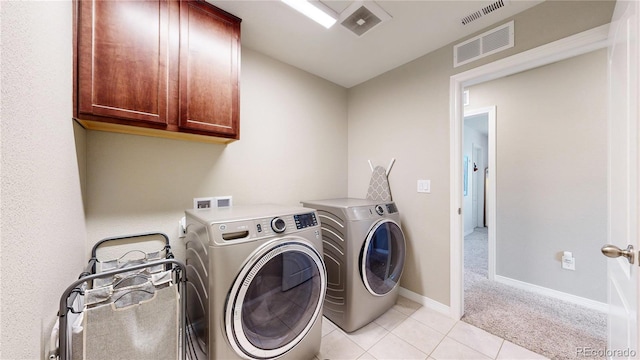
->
449, 24, 609, 319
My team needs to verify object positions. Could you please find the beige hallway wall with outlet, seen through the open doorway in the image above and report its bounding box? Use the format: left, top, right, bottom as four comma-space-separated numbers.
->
469, 50, 607, 302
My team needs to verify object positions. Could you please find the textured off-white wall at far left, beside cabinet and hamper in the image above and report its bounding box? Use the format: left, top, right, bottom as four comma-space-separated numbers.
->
0, 1, 86, 359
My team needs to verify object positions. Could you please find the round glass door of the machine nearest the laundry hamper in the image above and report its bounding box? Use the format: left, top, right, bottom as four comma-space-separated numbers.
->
225, 238, 327, 359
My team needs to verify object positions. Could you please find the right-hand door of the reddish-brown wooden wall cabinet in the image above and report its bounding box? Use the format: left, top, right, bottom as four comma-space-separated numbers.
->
178, 1, 240, 139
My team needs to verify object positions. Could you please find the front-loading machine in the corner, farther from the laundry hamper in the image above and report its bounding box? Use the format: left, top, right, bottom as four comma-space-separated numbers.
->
302, 198, 406, 332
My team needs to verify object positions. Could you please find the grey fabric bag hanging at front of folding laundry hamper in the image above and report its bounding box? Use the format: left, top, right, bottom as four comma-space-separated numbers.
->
82, 274, 179, 360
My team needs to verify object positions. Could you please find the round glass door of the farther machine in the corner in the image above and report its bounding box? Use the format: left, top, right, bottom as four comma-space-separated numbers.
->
360, 219, 406, 296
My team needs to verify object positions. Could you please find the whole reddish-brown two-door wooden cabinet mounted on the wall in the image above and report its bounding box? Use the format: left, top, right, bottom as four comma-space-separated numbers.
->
74, 0, 241, 142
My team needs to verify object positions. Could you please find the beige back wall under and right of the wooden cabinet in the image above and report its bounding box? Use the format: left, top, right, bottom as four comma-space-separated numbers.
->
85, 47, 347, 257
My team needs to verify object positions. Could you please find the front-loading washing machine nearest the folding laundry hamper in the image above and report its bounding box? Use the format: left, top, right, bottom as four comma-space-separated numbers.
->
185, 205, 326, 360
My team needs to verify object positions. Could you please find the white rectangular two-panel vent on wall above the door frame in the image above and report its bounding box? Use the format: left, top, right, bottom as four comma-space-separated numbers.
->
453, 21, 514, 67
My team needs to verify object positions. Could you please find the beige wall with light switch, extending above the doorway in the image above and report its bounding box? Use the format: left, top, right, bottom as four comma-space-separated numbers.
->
348, 1, 615, 306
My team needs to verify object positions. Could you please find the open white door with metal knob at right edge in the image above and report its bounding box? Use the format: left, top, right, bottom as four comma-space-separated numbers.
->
603, 0, 640, 359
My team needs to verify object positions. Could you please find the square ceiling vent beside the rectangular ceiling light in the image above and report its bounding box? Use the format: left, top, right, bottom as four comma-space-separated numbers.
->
339, 1, 391, 36
